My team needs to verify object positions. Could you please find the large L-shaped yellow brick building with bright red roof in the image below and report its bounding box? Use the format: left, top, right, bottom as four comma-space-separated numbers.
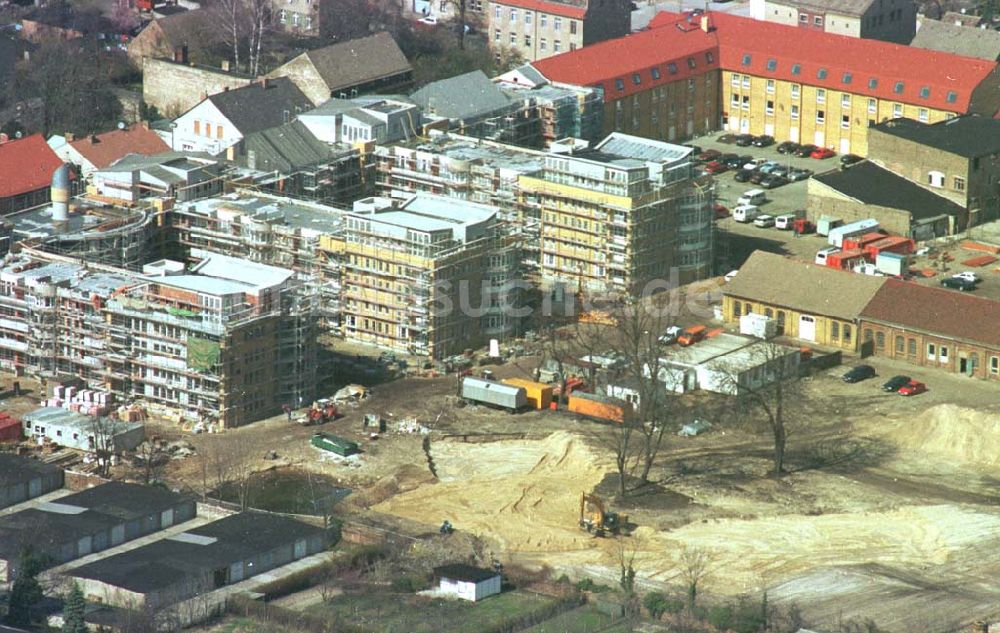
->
534, 13, 1000, 155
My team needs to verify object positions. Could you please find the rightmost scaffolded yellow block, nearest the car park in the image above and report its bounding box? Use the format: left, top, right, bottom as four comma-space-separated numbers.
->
518, 134, 713, 293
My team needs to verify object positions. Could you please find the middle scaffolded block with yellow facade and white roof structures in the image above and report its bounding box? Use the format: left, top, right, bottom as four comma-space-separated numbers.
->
322, 194, 521, 358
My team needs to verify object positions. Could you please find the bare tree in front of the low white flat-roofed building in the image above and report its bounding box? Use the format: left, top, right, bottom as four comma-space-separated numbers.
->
719, 341, 802, 477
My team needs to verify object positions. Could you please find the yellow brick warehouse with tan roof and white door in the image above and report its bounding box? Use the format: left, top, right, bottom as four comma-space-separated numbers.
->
722, 251, 886, 352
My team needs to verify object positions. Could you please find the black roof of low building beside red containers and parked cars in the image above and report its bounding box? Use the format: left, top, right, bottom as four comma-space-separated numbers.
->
813, 161, 965, 220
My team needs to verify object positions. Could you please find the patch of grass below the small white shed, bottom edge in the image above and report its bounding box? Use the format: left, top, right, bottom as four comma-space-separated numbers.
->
308, 591, 553, 633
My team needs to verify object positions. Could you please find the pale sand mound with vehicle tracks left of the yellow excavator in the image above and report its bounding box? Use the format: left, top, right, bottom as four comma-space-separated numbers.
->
373, 432, 611, 552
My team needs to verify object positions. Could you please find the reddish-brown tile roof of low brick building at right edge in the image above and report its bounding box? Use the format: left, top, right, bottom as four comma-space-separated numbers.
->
861, 279, 1000, 349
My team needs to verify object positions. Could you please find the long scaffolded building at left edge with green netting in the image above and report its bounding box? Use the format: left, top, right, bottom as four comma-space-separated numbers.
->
0, 253, 316, 427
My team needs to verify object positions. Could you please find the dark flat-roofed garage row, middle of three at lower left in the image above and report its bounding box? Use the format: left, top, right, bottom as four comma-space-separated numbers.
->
0, 482, 195, 582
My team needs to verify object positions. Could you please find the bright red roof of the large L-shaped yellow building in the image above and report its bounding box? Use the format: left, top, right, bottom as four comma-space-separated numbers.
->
533, 12, 997, 112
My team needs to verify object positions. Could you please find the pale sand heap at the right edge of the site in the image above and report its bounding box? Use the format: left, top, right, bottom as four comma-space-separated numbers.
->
888, 404, 1000, 469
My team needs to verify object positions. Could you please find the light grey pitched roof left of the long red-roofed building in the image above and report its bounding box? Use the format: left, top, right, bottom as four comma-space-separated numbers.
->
410, 70, 512, 120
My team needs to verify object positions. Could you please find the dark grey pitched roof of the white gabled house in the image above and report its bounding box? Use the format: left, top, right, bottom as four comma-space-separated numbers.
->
208, 77, 312, 136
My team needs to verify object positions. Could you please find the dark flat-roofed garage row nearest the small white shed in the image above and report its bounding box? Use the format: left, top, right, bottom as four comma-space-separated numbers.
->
71, 512, 326, 611
